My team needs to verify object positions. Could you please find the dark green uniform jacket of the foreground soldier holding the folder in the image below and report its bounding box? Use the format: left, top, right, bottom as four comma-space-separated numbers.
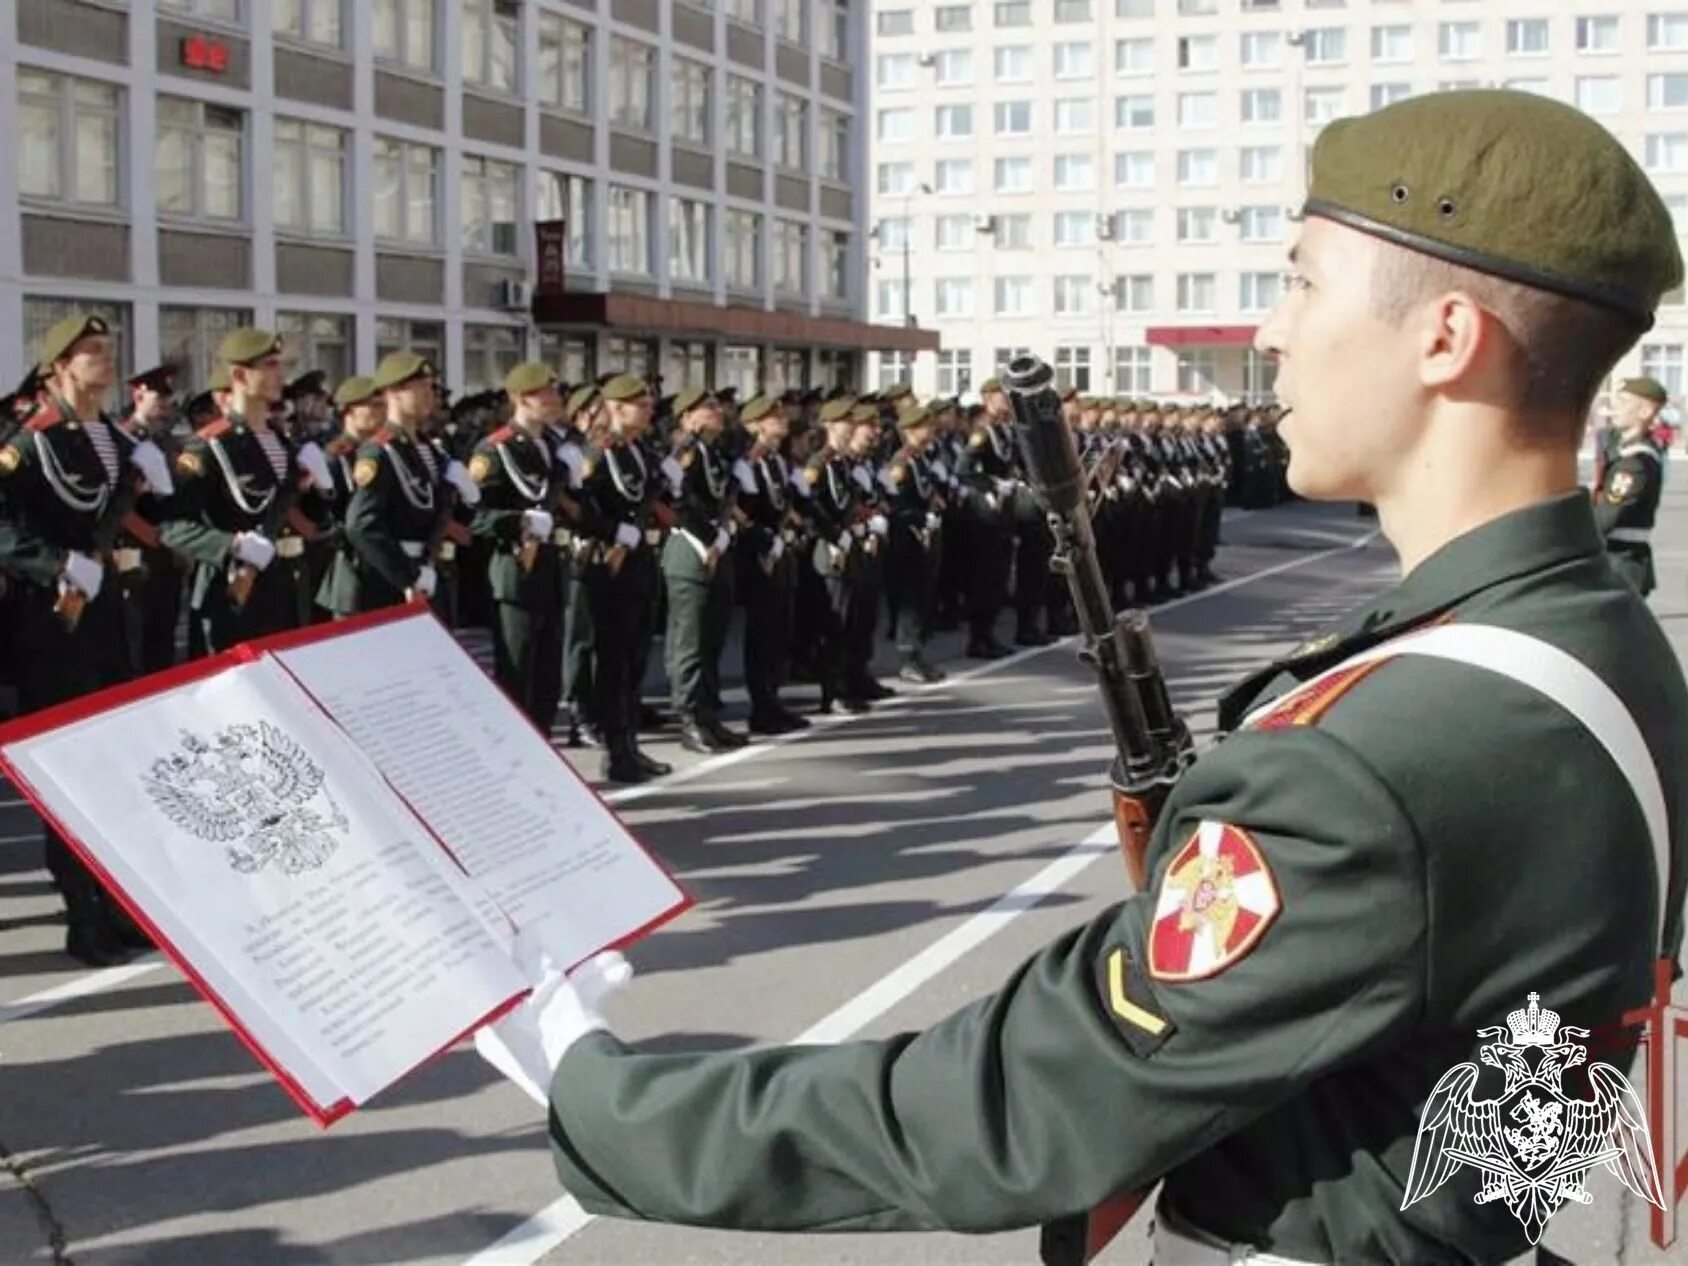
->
550, 491, 1688, 1263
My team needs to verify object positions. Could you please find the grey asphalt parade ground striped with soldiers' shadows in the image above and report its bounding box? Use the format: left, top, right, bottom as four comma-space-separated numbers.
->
0, 489, 1688, 1266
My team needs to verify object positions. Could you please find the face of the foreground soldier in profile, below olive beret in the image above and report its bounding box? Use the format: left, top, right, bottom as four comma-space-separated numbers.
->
1254, 216, 1411, 501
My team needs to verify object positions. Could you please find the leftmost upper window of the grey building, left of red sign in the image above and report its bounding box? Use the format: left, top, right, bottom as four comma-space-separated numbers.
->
17, 68, 122, 206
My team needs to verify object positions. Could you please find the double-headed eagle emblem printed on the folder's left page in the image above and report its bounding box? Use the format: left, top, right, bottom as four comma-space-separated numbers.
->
140, 721, 349, 874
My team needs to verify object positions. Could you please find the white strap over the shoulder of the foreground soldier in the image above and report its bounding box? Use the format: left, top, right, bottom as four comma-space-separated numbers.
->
1249, 625, 1671, 940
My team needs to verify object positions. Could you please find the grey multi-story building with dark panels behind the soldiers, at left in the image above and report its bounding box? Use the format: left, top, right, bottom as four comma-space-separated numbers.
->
0, 0, 935, 392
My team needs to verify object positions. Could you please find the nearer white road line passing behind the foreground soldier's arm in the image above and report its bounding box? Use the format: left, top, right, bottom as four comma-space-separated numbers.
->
464, 824, 1119, 1266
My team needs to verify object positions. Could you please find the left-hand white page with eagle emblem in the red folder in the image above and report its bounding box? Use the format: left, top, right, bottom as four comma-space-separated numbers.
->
7, 660, 527, 1107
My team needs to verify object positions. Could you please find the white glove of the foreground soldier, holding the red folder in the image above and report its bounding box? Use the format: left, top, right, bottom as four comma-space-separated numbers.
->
474, 933, 633, 1107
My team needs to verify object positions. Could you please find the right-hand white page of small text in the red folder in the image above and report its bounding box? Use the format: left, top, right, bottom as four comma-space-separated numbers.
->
277, 613, 684, 964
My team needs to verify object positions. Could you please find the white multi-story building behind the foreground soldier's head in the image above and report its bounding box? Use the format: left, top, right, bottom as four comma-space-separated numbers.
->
864, 0, 1688, 397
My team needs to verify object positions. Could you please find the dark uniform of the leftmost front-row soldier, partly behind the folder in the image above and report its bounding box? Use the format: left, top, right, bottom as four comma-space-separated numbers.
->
0, 376, 142, 966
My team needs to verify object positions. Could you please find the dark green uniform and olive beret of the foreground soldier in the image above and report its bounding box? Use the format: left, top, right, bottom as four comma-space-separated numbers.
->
549, 93, 1688, 1266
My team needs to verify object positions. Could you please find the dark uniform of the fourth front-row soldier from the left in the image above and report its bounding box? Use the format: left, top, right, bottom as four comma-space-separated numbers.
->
469, 425, 572, 736
